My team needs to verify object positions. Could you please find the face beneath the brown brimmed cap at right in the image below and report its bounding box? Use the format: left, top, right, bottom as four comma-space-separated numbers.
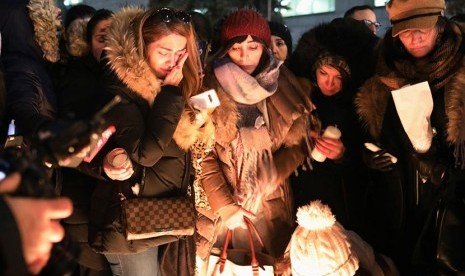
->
399, 27, 438, 58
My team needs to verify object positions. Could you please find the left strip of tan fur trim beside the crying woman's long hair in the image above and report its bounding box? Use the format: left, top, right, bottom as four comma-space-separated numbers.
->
105, 7, 161, 105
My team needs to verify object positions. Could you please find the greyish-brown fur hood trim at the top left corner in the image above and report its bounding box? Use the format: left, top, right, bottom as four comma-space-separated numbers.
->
27, 0, 60, 63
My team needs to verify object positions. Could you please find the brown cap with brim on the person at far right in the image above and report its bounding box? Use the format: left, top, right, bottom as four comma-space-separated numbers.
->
386, 0, 446, 36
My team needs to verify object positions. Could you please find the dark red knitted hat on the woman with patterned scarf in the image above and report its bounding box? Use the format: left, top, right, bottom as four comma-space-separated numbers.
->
221, 9, 271, 46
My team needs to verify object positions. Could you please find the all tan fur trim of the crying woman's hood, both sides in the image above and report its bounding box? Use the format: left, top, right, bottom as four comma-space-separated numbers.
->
105, 7, 215, 150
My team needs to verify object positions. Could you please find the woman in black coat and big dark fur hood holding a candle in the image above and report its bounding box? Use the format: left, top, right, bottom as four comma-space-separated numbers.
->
289, 18, 377, 231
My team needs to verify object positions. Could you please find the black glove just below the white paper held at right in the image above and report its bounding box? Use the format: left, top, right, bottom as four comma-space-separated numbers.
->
411, 153, 447, 185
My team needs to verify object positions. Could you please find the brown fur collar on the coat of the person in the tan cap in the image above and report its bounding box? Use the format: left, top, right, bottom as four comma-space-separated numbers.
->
355, 54, 465, 143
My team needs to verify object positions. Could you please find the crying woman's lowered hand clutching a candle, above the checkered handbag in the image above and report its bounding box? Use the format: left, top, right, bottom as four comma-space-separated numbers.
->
103, 148, 134, 181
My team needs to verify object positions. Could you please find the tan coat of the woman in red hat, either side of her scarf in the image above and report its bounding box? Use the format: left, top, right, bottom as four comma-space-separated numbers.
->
198, 66, 312, 257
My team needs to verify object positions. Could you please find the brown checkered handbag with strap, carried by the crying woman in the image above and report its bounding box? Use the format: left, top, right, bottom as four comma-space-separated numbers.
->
120, 155, 195, 240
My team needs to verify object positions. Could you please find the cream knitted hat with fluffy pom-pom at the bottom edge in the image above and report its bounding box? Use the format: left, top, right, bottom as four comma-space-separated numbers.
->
290, 200, 359, 276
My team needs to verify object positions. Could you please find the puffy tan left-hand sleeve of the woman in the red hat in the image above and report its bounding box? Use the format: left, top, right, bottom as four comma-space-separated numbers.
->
200, 149, 235, 212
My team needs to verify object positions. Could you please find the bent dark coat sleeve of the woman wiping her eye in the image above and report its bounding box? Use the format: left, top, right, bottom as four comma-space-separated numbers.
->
112, 85, 185, 167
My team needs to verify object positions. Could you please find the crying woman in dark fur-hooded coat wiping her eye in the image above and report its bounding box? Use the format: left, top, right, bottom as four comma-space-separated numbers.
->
89, 8, 214, 276
